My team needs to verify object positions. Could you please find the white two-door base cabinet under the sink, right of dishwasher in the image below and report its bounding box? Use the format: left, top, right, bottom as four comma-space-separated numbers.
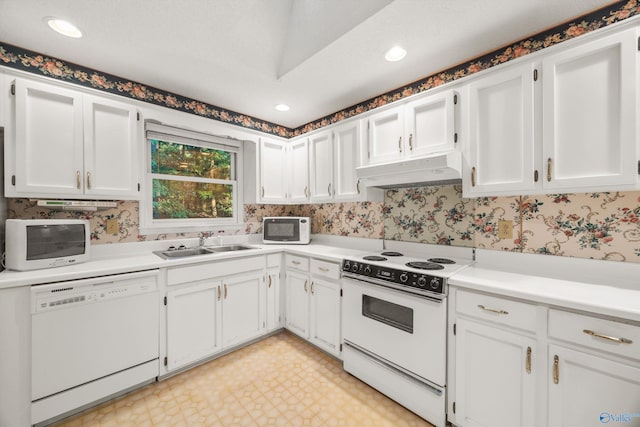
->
164, 256, 268, 373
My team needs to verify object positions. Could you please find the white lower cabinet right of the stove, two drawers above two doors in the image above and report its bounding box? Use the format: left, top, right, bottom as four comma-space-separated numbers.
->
447, 287, 640, 427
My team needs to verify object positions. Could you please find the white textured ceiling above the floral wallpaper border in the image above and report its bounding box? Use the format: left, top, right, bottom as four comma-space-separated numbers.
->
0, 0, 612, 128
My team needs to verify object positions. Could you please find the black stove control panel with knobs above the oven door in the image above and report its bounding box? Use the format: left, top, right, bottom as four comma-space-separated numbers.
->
342, 260, 445, 294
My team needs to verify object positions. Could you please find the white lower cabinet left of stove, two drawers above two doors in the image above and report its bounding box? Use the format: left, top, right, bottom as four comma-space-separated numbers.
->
285, 255, 342, 356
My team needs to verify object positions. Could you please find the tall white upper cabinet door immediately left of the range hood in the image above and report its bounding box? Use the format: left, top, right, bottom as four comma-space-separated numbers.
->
333, 120, 362, 200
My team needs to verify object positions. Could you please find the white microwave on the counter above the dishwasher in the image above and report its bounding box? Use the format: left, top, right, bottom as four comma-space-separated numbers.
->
5, 219, 91, 271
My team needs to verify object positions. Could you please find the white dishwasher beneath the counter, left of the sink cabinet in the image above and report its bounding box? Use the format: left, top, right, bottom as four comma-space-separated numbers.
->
31, 270, 159, 424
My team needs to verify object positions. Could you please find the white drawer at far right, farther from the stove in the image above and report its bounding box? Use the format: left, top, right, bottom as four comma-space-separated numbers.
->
549, 309, 640, 359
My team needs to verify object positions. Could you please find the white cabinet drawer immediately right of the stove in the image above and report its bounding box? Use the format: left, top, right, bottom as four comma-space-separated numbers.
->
456, 290, 536, 332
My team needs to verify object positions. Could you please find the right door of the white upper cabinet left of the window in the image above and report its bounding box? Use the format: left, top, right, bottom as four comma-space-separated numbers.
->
84, 96, 140, 197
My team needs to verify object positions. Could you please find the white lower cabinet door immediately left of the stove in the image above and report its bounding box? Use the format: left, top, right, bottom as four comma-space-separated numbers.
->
309, 278, 340, 355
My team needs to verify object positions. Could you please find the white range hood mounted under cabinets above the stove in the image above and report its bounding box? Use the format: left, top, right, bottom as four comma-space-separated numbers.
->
356, 151, 462, 188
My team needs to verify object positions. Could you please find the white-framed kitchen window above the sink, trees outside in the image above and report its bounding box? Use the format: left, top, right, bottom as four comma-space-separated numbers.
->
140, 123, 242, 234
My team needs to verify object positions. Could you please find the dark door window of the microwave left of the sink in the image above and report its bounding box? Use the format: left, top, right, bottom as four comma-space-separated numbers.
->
27, 224, 86, 261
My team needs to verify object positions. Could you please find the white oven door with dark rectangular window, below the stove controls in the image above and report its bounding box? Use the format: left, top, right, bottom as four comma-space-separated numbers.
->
342, 278, 447, 386
